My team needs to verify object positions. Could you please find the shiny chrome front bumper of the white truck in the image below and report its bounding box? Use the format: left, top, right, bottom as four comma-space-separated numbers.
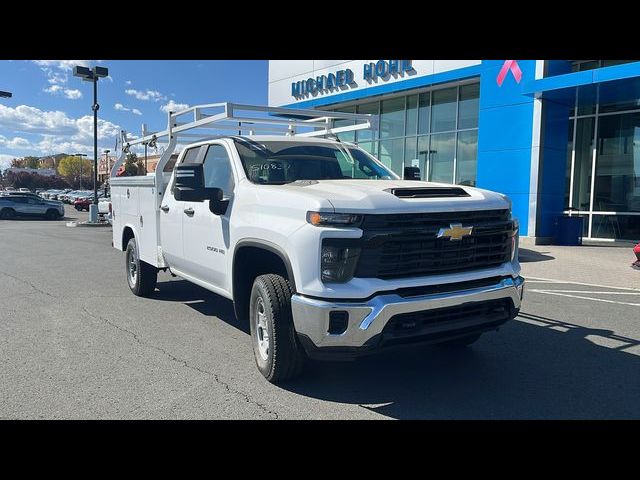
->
291, 277, 524, 348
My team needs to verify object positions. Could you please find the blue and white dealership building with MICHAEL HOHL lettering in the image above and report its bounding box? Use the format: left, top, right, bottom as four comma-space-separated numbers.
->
269, 60, 640, 243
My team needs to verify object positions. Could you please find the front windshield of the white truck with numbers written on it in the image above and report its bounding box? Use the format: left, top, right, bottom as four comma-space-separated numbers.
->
235, 139, 398, 185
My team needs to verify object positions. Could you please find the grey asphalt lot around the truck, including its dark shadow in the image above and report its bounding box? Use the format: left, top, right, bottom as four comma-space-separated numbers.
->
0, 212, 640, 419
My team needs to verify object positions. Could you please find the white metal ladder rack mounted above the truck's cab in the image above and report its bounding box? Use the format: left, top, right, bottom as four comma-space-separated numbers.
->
111, 102, 377, 178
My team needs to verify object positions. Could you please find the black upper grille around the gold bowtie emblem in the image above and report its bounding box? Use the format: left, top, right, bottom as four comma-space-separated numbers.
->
355, 210, 514, 279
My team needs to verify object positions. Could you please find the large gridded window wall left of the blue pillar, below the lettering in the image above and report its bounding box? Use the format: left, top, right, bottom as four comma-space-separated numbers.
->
334, 82, 480, 186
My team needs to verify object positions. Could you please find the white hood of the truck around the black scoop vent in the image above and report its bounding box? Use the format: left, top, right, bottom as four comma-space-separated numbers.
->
282, 180, 511, 213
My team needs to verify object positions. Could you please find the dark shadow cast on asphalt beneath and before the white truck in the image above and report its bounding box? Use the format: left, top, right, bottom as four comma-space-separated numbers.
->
154, 280, 640, 419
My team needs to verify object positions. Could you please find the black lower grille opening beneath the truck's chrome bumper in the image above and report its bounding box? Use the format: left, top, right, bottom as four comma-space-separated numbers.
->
382, 298, 513, 343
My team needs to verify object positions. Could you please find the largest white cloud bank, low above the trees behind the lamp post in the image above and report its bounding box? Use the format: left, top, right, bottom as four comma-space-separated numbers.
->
0, 104, 120, 155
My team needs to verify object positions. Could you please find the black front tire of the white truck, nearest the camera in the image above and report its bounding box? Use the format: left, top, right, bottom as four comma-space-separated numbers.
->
249, 274, 305, 384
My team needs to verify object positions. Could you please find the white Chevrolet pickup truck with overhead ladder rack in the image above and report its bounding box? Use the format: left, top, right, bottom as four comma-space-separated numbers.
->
111, 104, 524, 383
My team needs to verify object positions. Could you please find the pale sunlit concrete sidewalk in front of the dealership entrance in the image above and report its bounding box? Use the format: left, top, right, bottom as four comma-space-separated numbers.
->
520, 243, 640, 289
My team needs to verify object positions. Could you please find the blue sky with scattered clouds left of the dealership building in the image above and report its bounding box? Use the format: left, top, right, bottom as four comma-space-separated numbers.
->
0, 60, 268, 169
